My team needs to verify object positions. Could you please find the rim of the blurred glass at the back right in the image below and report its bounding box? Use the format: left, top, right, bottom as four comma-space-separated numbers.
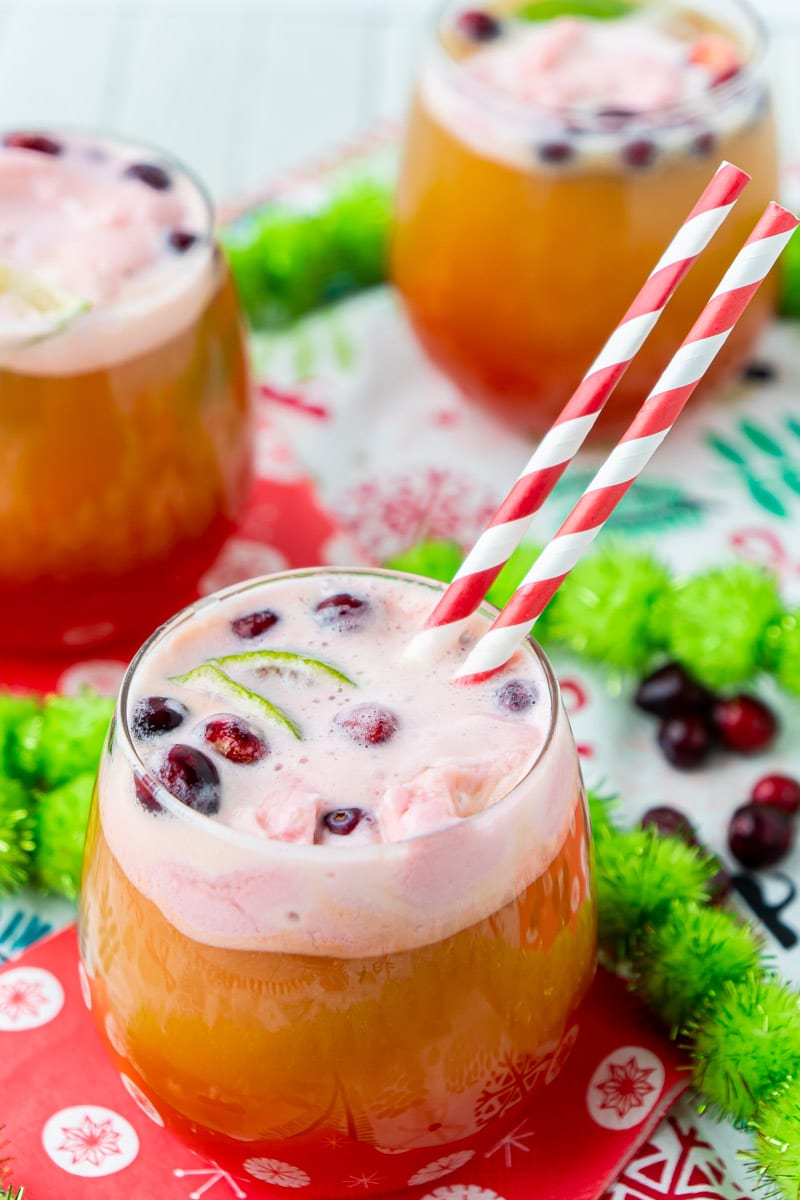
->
427, 0, 768, 133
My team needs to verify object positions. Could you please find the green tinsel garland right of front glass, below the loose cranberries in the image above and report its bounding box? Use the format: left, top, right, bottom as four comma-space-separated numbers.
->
589, 794, 800, 1200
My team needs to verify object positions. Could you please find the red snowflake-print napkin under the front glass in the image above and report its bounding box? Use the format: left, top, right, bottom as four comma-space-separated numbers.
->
0, 928, 714, 1200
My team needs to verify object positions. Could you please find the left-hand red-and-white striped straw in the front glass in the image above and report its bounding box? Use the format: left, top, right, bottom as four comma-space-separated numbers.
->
425, 162, 750, 648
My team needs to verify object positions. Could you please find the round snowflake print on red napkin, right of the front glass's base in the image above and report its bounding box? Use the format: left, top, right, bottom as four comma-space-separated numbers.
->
587, 1046, 664, 1129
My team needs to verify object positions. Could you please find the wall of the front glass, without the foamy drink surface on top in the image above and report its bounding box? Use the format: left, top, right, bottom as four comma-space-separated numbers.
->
79, 569, 596, 1200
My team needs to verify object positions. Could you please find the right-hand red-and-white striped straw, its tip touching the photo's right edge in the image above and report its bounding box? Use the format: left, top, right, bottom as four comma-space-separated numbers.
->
456, 203, 800, 679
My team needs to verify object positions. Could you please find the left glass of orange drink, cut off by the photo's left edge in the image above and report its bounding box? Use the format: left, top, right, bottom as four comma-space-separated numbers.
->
0, 130, 251, 654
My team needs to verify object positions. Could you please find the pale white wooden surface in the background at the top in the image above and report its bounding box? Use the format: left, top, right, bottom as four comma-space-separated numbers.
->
0, 0, 800, 198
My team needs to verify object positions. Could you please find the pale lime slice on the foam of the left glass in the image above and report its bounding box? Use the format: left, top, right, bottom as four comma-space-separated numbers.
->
0, 263, 91, 349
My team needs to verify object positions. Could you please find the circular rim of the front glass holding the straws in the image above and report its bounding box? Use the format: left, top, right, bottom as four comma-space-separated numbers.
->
113, 566, 563, 866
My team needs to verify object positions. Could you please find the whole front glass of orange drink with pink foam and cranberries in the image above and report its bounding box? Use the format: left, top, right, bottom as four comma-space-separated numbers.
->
80, 570, 595, 1198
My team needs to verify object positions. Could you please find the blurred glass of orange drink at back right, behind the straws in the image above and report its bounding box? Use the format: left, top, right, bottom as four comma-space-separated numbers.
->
392, 0, 777, 437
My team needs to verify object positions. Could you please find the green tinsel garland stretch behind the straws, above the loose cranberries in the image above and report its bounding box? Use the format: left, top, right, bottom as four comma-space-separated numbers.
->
386, 540, 800, 696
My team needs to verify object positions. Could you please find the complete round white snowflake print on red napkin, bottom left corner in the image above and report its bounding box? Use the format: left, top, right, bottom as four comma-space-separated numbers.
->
42, 1104, 139, 1178
